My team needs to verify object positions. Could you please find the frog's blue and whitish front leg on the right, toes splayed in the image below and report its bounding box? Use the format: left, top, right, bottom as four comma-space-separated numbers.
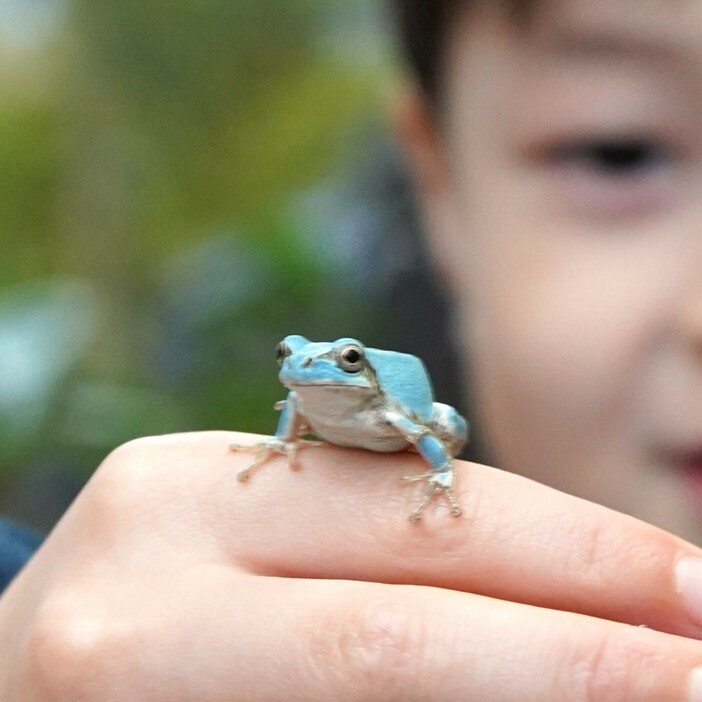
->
385, 410, 463, 523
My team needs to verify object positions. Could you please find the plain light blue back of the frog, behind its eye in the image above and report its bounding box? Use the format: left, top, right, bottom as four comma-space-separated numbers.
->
366, 348, 434, 422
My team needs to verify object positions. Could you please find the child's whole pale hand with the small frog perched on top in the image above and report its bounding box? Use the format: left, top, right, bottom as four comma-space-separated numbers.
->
0, 432, 702, 702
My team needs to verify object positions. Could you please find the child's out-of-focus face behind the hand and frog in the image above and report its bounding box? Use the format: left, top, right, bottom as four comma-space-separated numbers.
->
414, 0, 702, 540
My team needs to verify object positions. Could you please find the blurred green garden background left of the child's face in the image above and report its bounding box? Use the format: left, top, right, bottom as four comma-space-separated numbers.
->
0, 0, 465, 531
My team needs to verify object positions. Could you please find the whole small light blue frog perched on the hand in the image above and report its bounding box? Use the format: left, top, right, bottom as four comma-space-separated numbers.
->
231, 335, 468, 522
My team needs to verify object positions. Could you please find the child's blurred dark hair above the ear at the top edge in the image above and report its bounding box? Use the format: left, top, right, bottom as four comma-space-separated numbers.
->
391, 0, 467, 103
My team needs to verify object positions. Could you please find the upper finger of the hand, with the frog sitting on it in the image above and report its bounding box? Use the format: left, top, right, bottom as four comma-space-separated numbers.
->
93, 432, 702, 648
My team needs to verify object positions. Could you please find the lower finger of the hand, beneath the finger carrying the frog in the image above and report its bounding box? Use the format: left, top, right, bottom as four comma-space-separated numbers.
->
30, 567, 702, 702
